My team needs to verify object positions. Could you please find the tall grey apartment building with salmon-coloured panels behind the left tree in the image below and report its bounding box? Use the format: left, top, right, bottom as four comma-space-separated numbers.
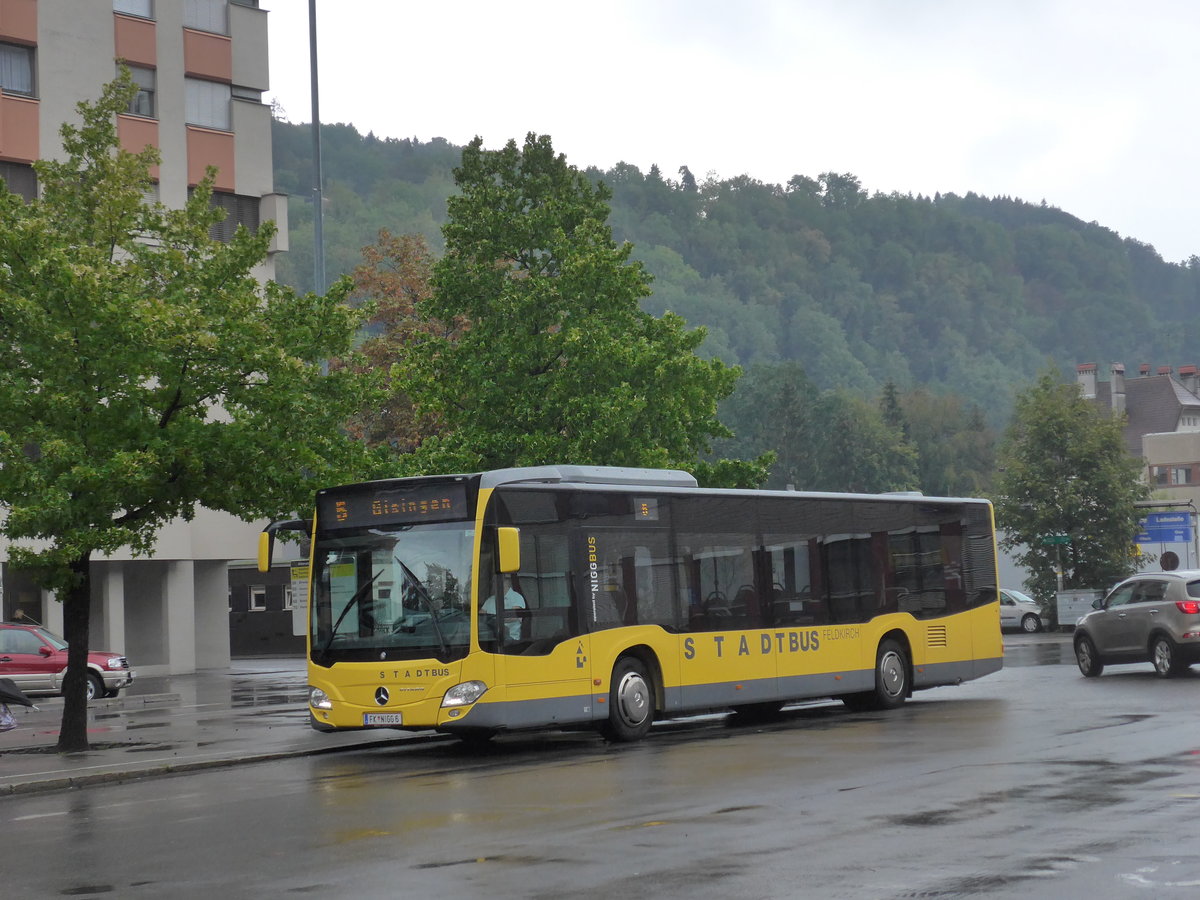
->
0, 0, 287, 674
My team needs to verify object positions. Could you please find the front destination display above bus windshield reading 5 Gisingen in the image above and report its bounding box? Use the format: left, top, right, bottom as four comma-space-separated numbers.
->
318, 482, 470, 528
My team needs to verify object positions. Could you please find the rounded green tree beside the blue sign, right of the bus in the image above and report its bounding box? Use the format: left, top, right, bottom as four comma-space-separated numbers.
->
996, 370, 1147, 604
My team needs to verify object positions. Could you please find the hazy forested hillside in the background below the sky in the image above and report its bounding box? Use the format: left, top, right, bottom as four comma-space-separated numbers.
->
275, 121, 1200, 427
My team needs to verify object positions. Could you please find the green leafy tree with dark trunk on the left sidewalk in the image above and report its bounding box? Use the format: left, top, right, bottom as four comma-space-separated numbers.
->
0, 73, 379, 751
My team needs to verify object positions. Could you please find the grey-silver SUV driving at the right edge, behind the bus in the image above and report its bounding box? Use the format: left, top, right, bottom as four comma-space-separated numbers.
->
1075, 569, 1200, 678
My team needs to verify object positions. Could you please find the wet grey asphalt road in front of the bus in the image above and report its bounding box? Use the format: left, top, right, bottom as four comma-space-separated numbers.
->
0, 636, 1200, 900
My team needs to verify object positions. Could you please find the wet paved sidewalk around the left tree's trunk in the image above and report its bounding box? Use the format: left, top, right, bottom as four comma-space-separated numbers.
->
0, 659, 440, 797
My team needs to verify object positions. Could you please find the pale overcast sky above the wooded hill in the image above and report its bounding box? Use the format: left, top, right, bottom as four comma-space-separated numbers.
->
262, 0, 1200, 262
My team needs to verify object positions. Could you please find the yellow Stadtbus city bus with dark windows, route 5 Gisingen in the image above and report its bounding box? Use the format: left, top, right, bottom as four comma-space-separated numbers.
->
259, 466, 1002, 740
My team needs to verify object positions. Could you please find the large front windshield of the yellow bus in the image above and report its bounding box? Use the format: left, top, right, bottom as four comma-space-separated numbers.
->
310, 522, 474, 666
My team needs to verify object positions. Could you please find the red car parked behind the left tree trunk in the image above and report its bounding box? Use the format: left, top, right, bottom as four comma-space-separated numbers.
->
0, 622, 137, 700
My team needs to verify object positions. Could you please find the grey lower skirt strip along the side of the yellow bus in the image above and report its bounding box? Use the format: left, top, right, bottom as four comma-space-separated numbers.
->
445, 659, 1003, 731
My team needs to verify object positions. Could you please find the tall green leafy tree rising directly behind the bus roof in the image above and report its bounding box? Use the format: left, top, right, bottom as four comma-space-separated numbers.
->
402, 134, 764, 484
